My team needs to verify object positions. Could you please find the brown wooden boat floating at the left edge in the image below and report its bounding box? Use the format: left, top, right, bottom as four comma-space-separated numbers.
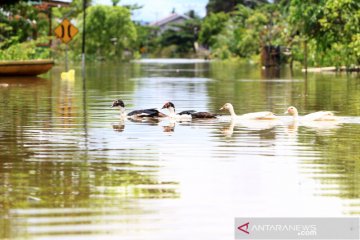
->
0, 59, 54, 76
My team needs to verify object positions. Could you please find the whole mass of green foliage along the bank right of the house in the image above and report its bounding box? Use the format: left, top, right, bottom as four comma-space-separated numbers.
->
199, 0, 360, 66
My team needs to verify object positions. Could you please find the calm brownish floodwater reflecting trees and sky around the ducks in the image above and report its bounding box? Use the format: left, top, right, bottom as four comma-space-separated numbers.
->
0, 60, 360, 240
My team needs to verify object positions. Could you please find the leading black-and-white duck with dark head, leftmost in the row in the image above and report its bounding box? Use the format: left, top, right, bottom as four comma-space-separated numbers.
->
111, 99, 167, 119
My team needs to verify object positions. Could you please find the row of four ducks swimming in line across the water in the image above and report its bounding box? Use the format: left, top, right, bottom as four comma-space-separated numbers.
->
111, 99, 337, 121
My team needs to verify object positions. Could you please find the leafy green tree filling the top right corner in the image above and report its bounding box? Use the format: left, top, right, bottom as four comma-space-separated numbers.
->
289, 0, 360, 66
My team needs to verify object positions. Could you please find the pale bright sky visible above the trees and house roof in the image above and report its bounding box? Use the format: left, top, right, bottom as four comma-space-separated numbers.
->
93, 0, 209, 22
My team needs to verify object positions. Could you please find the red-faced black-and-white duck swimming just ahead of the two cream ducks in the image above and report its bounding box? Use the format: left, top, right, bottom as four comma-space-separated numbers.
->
162, 102, 216, 121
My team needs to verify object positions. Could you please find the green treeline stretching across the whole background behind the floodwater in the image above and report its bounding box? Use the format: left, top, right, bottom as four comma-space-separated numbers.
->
0, 0, 360, 67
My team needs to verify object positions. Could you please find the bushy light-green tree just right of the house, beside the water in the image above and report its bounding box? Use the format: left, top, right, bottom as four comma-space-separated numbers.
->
208, 4, 283, 58
